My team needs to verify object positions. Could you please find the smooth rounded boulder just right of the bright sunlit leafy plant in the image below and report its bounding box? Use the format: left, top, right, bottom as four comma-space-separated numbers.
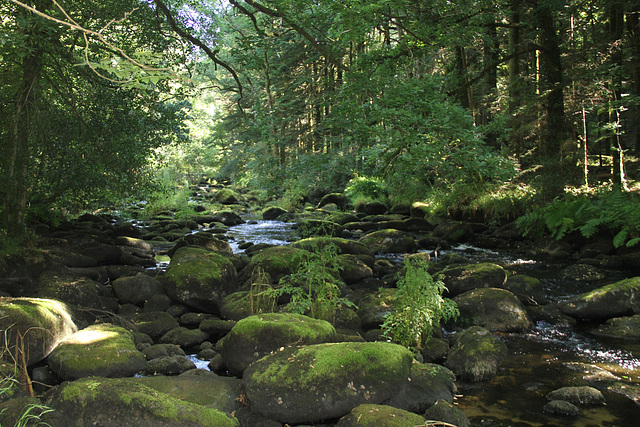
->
453, 288, 533, 332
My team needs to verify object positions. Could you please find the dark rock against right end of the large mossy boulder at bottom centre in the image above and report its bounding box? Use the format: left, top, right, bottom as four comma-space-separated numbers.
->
383, 362, 457, 414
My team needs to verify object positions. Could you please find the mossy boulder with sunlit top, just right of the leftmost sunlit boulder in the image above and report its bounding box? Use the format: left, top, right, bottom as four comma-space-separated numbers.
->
48, 323, 147, 380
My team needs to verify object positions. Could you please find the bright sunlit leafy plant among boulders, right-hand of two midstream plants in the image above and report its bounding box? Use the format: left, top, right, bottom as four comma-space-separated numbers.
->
382, 260, 460, 348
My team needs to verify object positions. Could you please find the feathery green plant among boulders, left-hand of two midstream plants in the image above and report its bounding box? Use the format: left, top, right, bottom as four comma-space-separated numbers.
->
274, 244, 355, 320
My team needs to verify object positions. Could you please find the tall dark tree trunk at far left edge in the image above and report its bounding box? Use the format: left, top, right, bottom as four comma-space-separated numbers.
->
4, 1, 44, 235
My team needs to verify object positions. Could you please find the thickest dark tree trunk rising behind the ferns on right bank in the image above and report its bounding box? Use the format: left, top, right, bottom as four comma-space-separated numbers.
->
534, 2, 567, 159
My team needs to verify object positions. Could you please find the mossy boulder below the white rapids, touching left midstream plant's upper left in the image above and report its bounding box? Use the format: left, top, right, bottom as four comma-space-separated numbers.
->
240, 245, 308, 283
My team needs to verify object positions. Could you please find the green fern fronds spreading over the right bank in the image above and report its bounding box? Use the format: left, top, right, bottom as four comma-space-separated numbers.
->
516, 190, 640, 248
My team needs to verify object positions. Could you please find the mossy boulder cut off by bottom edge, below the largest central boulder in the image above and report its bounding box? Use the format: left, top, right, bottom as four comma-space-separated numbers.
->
336, 403, 425, 427
